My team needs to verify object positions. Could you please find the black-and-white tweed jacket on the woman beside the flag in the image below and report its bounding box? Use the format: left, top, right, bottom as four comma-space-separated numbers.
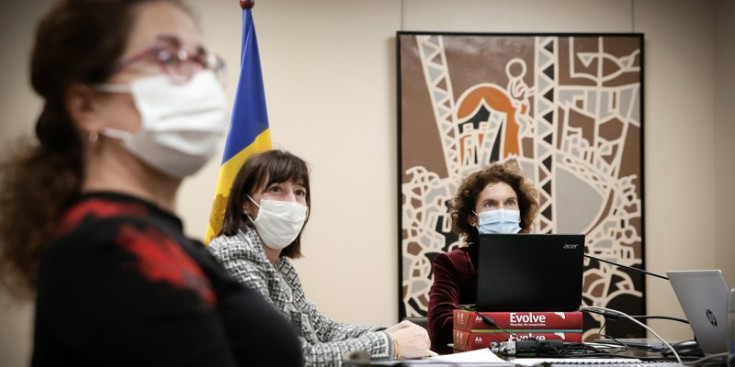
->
208, 228, 393, 367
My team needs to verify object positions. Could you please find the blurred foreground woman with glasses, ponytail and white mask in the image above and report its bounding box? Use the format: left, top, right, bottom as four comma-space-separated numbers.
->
0, 0, 302, 366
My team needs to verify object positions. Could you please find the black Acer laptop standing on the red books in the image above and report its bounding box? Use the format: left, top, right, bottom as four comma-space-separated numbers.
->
475, 234, 584, 312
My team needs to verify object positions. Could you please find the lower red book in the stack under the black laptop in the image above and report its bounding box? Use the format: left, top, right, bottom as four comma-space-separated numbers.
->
452, 330, 582, 352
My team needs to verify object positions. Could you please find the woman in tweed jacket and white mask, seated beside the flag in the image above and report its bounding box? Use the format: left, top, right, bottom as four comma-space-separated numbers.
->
208, 150, 429, 366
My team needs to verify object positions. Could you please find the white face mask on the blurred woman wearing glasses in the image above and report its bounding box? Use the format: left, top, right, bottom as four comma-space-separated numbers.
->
96, 70, 227, 178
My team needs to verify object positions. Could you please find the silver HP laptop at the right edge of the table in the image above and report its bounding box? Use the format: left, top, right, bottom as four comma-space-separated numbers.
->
666, 270, 728, 354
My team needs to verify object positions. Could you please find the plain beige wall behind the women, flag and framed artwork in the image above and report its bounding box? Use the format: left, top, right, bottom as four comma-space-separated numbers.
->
0, 0, 735, 366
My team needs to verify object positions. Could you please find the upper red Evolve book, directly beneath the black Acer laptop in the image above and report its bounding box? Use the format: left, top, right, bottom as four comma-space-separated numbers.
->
454, 310, 582, 332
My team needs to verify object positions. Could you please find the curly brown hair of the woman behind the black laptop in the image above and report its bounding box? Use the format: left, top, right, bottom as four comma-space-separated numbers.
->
448, 161, 538, 242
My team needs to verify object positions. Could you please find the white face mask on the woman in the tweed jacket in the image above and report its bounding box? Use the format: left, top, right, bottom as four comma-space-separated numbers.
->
248, 195, 307, 250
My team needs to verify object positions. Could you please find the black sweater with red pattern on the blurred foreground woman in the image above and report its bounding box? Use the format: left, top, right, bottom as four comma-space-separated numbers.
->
32, 193, 303, 366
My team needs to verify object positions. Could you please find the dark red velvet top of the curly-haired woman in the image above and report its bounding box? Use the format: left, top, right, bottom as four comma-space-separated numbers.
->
428, 244, 477, 353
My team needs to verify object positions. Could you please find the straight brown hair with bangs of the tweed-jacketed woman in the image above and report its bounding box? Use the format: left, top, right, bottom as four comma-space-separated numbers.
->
218, 150, 311, 259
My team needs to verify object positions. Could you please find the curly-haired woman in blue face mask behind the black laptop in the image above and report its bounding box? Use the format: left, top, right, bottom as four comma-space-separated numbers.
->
428, 162, 538, 353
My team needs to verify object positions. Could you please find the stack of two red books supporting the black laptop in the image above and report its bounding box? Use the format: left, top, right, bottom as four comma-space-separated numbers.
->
453, 310, 583, 352
